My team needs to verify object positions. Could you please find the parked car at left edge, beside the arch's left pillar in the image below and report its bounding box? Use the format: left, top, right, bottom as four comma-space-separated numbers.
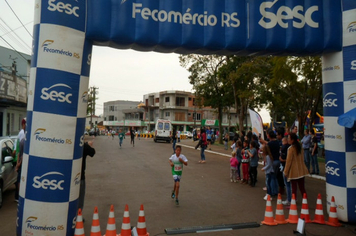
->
0, 138, 17, 208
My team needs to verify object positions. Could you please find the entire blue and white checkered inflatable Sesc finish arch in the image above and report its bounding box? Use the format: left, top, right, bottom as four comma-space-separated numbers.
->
17, 0, 356, 235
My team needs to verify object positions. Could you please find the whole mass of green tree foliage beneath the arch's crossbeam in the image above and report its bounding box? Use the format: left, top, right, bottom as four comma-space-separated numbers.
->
179, 55, 322, 138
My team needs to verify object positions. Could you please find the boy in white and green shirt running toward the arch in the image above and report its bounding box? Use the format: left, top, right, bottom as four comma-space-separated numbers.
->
169, 145, 188, 206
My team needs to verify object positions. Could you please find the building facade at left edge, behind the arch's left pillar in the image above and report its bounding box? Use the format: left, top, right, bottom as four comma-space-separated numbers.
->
0, 47, 31, 136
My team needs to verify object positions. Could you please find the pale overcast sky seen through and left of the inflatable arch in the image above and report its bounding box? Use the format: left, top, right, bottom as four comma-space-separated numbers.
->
0, 0, 270, 122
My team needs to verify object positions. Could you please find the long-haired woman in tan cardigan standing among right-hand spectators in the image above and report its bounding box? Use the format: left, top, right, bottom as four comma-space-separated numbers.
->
284, 133, 309, 198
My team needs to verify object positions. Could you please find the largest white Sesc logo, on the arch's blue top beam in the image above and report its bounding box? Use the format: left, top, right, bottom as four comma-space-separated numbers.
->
258, 0, 319, 29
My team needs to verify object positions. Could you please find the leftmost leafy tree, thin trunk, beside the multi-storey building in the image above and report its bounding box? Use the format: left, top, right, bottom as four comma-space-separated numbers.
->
179, 54, 232, 144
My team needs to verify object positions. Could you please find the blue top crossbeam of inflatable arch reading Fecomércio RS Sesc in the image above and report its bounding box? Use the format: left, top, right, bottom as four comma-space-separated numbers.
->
86, 0, 342, 55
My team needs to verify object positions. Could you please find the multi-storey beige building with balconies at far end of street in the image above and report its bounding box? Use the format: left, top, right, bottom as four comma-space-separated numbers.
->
104, 90, 250, 132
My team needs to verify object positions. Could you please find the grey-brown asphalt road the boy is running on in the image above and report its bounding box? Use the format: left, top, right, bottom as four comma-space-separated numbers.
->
0, 136, 356, 236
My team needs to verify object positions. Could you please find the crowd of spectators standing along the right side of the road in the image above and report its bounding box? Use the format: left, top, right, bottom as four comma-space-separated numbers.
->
225, 127, 319, 206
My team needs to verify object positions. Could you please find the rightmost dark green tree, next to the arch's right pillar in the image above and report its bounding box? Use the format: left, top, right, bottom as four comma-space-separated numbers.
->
268, 56, 322, 136
